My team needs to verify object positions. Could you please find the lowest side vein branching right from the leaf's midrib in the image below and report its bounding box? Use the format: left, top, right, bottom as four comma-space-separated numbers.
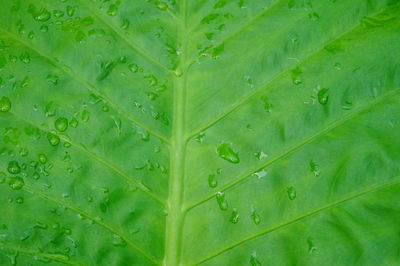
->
193, 176, 400, 265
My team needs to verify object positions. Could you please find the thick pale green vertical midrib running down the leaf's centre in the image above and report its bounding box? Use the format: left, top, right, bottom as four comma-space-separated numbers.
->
163, 0, 187, 266
